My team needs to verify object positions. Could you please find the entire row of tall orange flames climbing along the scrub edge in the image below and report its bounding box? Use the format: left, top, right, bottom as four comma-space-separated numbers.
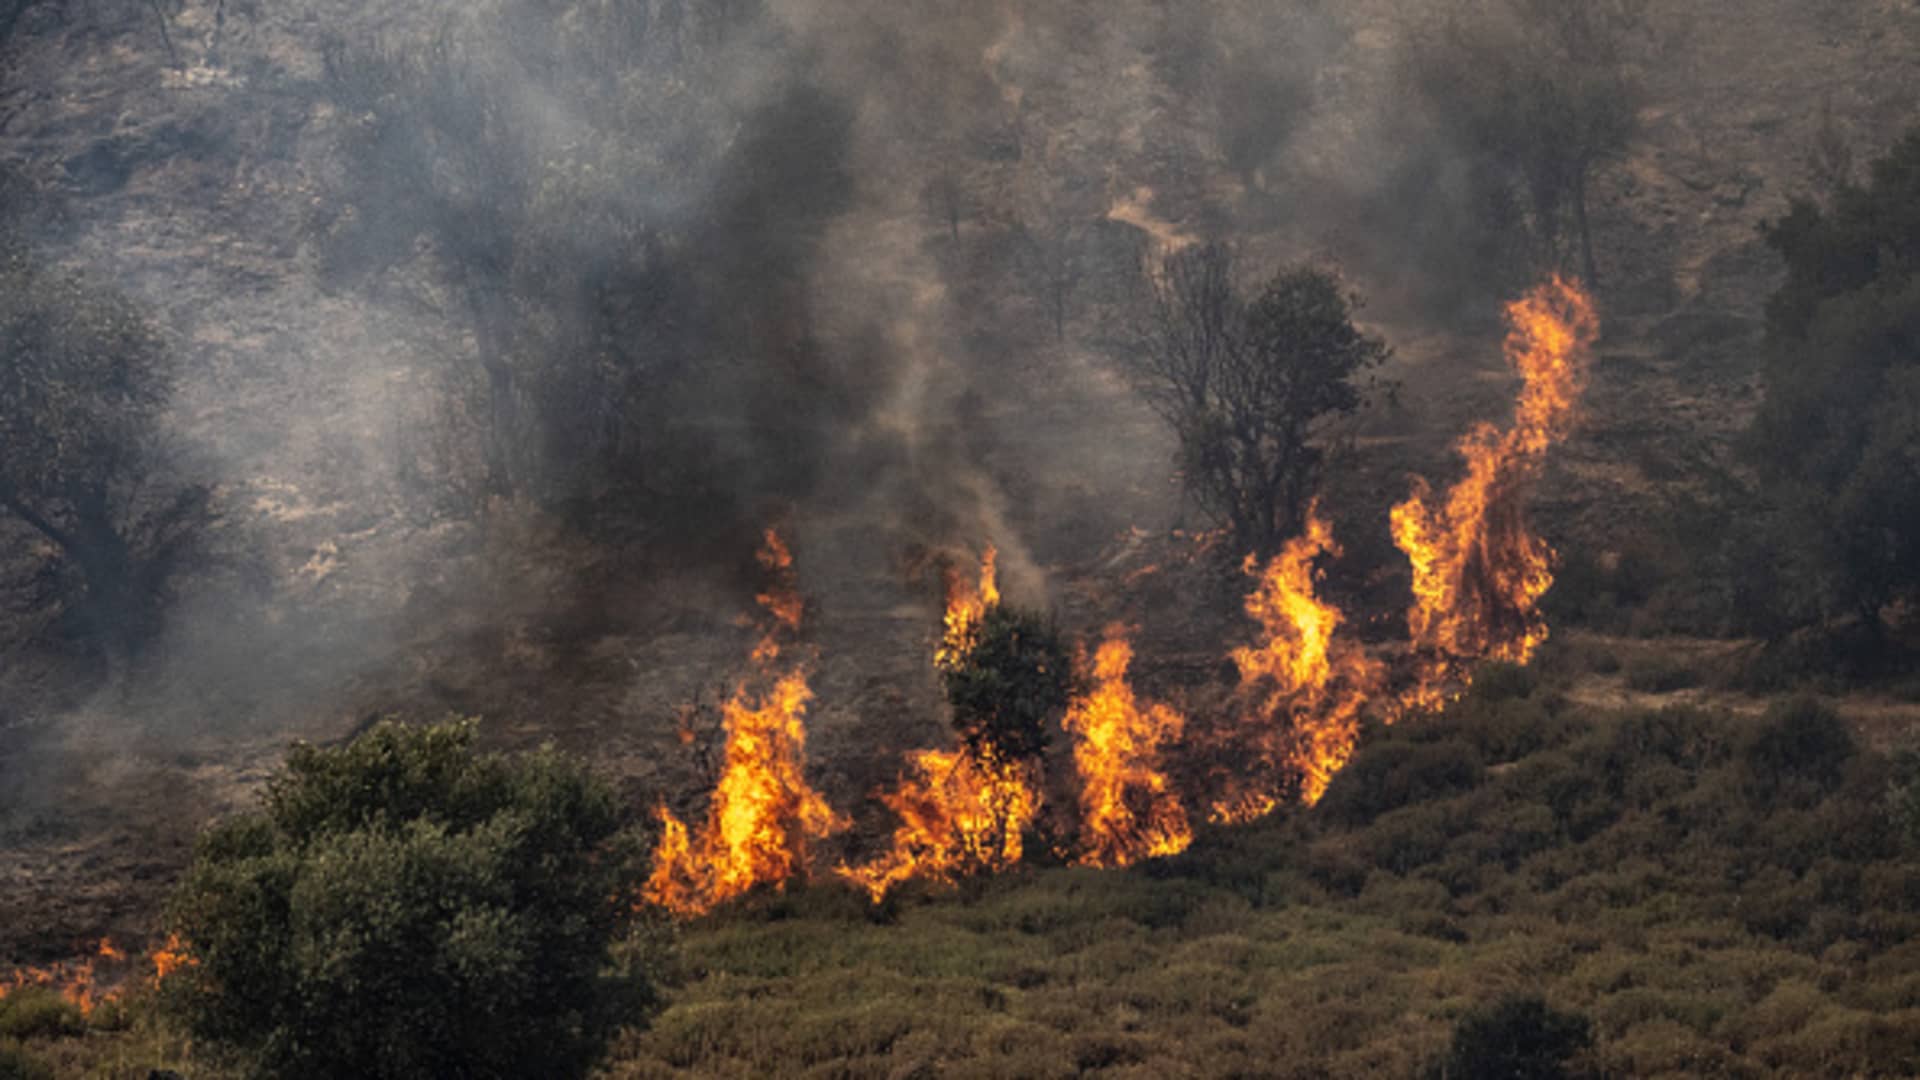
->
647, 277, 1599, 915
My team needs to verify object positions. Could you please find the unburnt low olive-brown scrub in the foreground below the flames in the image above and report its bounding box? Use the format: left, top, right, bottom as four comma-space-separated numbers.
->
0, 665, 1920, 1076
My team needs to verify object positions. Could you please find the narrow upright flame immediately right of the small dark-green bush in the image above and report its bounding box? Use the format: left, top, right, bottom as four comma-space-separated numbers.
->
1064, 626, 1192, 867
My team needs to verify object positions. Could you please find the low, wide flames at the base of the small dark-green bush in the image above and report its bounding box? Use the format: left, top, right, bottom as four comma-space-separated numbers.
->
837, 737, 1041, 903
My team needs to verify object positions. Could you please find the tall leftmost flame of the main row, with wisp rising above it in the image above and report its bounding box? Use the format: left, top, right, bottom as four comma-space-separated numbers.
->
641, 530, 845, 917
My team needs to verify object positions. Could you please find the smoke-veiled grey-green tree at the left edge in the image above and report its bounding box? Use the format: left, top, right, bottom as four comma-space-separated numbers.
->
0, 236, 207, 650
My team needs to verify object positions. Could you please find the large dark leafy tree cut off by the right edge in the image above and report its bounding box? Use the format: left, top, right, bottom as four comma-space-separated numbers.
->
1745, 131, 1920, 630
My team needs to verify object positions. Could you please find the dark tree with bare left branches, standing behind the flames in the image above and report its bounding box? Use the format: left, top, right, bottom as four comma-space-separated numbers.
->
1125, 244, 1392, 553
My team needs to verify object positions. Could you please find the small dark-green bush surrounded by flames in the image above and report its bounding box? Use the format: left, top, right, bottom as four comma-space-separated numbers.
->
943, 603, 1075, 761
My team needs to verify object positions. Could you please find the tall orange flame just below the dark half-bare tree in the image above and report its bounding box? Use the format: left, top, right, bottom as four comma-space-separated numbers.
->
1212, 505, 1382, 810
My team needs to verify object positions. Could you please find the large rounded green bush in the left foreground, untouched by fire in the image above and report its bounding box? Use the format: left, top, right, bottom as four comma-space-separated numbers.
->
167, 721, 651, 1078
